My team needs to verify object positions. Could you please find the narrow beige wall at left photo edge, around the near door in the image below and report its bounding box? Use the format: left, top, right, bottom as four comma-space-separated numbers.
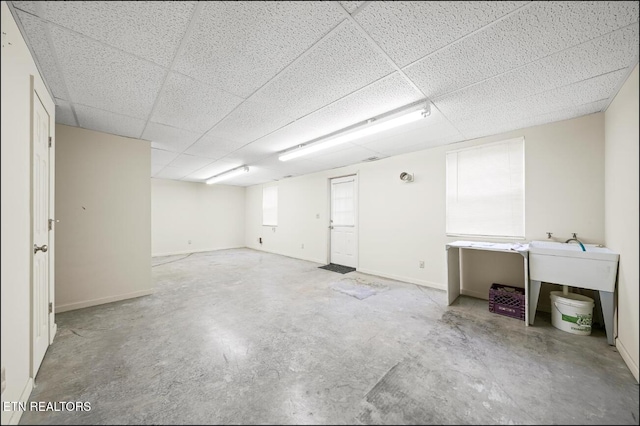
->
0, 1, 55, 424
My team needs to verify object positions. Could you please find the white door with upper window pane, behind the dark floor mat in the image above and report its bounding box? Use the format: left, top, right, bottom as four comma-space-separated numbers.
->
329, 175, 358, 268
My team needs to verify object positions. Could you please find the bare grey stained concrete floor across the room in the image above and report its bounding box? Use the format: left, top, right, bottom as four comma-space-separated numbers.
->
21, 249, 640, 425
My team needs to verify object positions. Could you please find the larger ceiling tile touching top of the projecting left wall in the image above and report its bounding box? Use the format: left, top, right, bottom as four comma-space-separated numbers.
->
74, 104, 144, 138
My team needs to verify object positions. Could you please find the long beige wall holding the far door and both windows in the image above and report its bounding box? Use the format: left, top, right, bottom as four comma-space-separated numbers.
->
245, 114, 604, 294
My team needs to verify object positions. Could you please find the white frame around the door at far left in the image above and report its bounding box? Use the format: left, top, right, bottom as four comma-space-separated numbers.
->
29, 75, 57, 379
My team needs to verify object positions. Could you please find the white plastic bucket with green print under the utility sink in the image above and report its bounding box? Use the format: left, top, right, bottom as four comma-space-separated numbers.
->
551, 291, 594, 336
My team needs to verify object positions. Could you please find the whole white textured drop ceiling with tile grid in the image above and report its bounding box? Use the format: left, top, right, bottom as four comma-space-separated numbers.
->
9, 1, 639, 186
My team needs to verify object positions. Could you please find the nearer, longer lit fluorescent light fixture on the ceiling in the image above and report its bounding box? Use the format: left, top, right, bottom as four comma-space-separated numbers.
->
278, 103, 431, 161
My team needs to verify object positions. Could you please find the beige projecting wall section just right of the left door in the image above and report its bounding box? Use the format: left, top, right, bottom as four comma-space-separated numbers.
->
56, 125, 152, 312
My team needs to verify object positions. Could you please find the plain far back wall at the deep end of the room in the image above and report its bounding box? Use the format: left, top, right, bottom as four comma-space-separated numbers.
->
151, 179, 245, 256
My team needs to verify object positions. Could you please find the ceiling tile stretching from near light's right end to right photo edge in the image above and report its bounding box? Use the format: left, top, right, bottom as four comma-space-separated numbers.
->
434, 24, 639, 116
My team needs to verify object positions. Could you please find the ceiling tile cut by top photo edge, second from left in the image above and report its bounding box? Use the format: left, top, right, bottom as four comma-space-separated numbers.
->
175, 1, 343, 97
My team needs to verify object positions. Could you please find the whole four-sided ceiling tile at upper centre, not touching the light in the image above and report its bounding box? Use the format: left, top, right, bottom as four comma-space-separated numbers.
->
252, 21, 394, 117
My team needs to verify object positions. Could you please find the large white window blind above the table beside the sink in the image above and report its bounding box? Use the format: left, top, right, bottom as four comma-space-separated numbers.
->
446, 138, 524, 238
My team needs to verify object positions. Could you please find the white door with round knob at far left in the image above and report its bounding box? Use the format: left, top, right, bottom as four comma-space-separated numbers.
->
31, 90, 50, 377
